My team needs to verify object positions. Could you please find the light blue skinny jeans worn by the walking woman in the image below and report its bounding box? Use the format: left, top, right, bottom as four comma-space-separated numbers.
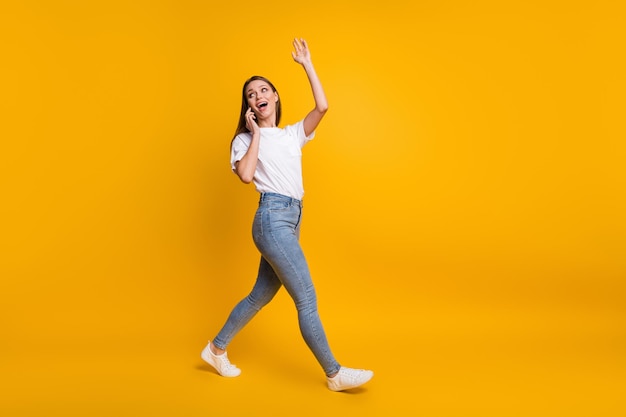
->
213, 193, 340, 375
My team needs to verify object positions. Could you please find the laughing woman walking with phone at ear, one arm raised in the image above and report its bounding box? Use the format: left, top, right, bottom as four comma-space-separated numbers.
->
201, 39, 373, 391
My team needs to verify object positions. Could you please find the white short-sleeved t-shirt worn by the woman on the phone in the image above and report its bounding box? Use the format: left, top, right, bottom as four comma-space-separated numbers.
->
230, 120, 315, 200
